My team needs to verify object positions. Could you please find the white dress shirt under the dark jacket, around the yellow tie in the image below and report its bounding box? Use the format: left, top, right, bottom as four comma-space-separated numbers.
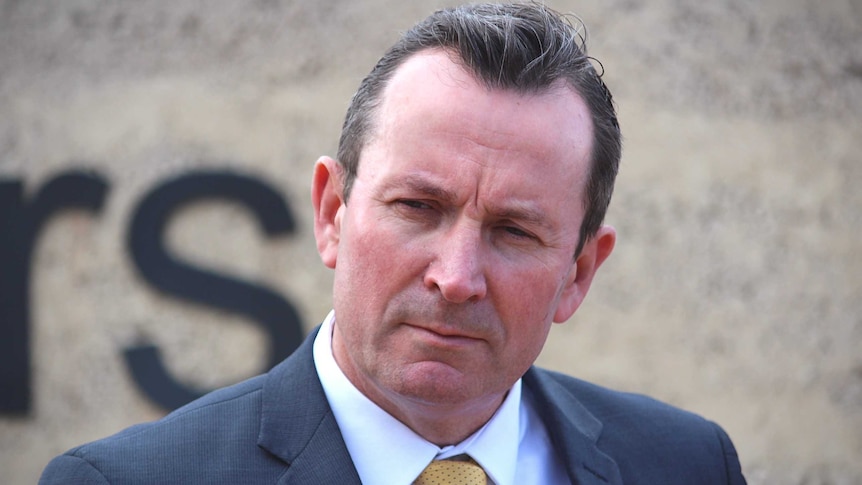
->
314, 312, 570, 485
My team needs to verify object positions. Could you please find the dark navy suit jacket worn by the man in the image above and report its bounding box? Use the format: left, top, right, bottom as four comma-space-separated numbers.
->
39, 332, 745, 485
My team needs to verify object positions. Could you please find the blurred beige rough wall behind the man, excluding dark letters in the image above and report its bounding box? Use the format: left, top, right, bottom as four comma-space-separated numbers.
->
0, 0, 862, 484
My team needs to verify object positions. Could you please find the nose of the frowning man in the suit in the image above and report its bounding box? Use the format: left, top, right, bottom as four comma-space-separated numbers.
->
424, 224, 488, 303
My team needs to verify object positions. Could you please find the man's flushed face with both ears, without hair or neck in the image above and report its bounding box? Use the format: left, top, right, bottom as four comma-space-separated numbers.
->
313, 51, 614, 424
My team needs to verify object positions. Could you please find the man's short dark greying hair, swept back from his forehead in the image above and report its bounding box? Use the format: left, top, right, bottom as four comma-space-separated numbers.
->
337, 3, 622, 256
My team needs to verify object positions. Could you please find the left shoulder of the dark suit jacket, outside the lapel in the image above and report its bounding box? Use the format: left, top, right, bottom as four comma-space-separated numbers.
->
40, 376, 284, 484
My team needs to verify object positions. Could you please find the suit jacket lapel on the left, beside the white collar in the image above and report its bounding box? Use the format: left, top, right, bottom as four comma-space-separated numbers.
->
258, 331, 360, 485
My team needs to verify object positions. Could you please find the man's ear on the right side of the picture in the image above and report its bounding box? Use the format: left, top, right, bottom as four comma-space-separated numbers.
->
554, 226, 617, 323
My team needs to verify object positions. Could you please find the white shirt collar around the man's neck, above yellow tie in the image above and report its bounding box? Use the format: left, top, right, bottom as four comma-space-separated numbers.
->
314, 312, 524, 485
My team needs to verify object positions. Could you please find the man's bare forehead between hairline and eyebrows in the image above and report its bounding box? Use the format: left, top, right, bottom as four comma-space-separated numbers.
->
362, 49, 593, 186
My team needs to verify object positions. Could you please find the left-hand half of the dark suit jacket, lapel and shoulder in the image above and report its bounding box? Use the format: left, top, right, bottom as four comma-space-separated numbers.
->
39, 328, 359, 484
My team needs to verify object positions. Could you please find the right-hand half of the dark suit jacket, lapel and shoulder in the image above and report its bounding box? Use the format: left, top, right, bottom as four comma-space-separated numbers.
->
524, 368, 745, 485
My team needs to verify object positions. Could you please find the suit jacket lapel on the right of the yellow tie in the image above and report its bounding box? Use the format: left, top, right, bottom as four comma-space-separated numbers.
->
524, 368, 622, 485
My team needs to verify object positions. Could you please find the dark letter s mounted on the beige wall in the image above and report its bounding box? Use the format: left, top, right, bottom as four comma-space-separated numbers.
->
124, 171, 302, 409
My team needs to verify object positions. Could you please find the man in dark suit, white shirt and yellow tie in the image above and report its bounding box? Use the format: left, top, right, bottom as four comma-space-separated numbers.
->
42, 4, 745, 485
